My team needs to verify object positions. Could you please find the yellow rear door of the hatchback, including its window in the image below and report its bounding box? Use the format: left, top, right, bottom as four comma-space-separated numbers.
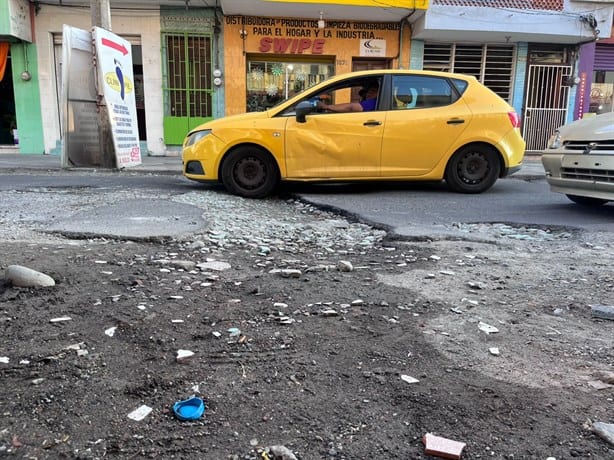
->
381, 75, 473, 177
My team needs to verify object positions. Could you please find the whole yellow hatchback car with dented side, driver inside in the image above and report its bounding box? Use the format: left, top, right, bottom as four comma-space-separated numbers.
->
183, 70, 525, 198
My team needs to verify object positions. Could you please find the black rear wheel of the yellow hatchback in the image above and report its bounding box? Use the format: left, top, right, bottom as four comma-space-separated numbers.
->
445, 145, 501, 193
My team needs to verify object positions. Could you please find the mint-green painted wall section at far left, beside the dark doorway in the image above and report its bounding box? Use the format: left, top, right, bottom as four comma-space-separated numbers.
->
11, 42, 45, 154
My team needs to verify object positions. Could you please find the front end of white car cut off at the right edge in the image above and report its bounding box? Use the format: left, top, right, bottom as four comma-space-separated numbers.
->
542, 112, 614, 206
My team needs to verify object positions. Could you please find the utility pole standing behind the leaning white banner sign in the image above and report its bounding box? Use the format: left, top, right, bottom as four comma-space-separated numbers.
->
90, 0, 117, 168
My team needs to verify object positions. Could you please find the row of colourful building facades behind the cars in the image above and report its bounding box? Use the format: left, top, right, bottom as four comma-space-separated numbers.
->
0, 0, 614, 155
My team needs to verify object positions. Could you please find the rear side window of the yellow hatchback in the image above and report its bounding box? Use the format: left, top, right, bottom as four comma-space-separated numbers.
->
392, 75, 457, 110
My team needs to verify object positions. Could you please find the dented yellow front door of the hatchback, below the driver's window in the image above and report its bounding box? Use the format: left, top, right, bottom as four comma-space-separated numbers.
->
285, 77, 386, 179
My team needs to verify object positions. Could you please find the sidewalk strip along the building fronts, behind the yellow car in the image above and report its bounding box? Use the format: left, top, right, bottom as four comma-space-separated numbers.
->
0, 153, 544, 179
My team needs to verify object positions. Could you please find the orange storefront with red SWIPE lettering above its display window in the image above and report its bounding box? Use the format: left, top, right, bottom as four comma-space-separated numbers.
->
224, 16, 410, 115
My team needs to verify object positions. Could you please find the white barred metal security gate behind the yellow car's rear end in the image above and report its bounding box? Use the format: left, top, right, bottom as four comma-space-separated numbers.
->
522, 65, 572, 151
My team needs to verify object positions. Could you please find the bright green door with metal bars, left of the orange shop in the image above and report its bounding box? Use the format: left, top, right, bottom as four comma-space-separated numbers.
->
162, 33, 213, 145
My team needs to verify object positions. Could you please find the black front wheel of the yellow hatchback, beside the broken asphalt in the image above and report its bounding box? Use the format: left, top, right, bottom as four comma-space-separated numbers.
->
221, 146, 279, 198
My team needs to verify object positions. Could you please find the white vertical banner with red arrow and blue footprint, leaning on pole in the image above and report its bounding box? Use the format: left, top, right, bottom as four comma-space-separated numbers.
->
94, 27, 141, 169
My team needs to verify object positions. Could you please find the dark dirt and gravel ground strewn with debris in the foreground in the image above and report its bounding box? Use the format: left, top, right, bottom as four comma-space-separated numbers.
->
0, 228, 614, 460
